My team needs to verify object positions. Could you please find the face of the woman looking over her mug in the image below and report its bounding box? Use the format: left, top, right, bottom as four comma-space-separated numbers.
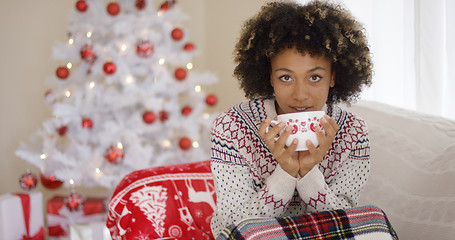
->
270, 48, 335, 114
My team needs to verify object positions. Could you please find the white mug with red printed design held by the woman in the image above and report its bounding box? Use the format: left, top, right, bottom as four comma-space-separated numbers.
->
271, 111, 325, 151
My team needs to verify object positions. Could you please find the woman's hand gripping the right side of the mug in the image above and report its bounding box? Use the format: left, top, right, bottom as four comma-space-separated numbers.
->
298, 115, 339, 177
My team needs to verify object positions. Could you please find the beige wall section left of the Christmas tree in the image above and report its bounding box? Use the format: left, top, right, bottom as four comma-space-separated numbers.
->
0, 0, 73, 197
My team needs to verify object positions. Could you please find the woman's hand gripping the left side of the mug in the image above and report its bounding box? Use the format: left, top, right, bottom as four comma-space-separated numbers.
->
258, 118, 299, 177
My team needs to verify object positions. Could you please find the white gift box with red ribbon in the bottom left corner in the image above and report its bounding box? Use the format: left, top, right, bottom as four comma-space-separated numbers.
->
0, 192, 45, 240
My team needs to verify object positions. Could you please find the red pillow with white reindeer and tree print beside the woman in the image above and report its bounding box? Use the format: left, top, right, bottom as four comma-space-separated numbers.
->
106, 161, 216, 239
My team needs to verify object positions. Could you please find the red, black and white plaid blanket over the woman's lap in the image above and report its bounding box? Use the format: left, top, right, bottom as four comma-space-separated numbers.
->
217, 206, 398, 240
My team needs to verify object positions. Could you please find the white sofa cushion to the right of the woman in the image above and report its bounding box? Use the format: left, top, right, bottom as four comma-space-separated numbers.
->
346, 101, 455, 240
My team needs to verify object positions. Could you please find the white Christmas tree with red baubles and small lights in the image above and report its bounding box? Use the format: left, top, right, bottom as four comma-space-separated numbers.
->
16, 0, 217, 188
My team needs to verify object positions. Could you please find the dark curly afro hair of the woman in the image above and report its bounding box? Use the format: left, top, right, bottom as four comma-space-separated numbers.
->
234, 1, 373, 104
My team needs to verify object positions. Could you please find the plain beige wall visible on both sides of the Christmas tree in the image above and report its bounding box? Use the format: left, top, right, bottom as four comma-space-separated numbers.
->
0, 0, 265, 200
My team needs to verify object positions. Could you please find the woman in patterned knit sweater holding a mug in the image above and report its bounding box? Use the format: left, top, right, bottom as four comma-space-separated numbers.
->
211, 1, 372, 236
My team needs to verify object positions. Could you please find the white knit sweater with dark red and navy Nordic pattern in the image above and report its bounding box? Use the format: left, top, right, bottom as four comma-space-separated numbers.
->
211, 99, 370, 236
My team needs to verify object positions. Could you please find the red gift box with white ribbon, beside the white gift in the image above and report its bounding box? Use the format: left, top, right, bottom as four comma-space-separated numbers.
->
47, 196, 106, 237
